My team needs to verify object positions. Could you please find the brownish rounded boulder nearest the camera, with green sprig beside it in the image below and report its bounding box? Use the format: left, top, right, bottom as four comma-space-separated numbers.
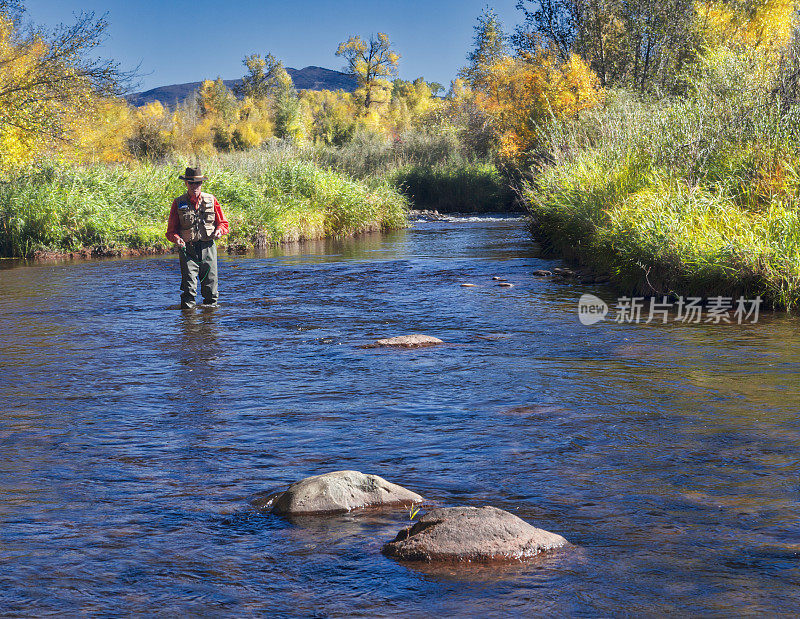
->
382, 507, 568, 563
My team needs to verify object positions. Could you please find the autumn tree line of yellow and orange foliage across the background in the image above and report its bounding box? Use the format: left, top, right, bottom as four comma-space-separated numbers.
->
0, 0, 800, 171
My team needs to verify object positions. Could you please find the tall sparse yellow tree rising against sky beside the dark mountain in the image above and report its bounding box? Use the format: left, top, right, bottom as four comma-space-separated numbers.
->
336, 32, 400, 112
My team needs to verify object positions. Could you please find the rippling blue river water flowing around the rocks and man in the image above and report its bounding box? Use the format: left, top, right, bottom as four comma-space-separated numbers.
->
0, 220, 800, 616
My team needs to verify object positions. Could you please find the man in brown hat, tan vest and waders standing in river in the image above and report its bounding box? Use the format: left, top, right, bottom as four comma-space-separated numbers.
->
167, 166, 228, 309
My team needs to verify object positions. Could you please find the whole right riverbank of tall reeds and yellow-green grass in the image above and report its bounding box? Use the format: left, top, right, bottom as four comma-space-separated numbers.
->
526, 76, 800, 308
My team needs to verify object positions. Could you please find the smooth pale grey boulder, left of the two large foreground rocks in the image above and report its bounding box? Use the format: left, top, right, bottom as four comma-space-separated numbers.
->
272, 471, 423, 515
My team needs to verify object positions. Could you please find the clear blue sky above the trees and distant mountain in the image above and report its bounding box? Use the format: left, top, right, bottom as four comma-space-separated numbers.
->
26, 0, 521, 90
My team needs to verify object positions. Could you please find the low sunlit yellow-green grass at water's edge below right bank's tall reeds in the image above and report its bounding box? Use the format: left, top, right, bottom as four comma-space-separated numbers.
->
527, 146, 800, 308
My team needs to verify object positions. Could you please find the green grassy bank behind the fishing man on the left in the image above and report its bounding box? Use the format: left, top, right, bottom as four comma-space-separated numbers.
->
0, 153, 407, 257
